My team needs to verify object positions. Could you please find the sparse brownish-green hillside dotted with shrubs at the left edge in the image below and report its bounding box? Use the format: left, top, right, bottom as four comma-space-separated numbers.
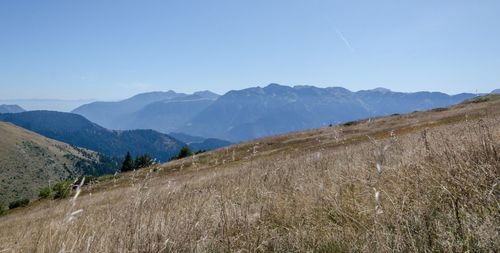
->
0, 122, 117, 207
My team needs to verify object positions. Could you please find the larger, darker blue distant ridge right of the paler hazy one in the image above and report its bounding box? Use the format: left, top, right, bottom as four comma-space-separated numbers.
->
184, 84, 474, 141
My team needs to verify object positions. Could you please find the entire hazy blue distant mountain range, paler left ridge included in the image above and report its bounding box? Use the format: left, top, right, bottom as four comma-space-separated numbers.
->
73, 84, 475, 142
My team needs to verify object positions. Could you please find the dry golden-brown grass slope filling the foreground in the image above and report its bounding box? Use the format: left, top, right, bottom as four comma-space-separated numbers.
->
0, 96, 500, 252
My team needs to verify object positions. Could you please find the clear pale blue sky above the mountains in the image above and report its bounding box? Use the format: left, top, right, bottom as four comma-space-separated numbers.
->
0, 0, 500, 99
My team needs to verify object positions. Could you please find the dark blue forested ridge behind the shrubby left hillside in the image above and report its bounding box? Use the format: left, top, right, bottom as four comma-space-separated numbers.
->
0, 111, 185, 161
